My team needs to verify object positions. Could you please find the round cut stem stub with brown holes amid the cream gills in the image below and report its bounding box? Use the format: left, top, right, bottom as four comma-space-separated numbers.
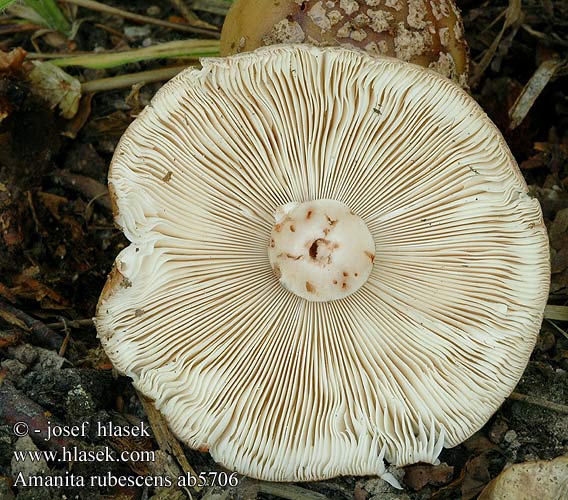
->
268, 200, 375, 302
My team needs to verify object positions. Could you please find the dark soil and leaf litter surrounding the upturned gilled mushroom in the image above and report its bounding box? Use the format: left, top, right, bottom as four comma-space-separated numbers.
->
0, 0, 568, 500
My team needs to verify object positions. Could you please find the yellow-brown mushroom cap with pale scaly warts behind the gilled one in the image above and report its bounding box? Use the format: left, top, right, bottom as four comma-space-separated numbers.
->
221, 0, 469, 87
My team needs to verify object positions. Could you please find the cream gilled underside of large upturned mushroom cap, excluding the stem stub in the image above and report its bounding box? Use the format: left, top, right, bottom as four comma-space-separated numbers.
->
95, 45, 549, 481
